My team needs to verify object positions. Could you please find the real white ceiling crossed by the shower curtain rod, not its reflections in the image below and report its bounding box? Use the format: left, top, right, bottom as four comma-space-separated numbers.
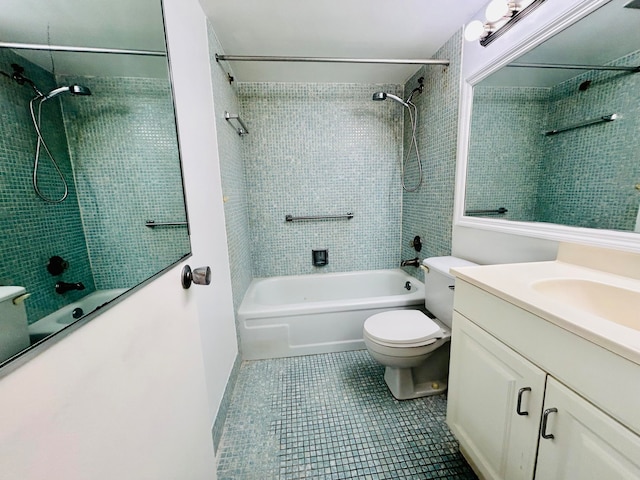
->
201, 0, 488, 84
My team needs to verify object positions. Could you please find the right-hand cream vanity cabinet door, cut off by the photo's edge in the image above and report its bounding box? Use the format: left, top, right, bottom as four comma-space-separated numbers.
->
536, 377, 640, 480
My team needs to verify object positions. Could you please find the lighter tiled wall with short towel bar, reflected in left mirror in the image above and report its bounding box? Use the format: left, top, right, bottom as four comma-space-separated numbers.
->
59, 77, 190, 289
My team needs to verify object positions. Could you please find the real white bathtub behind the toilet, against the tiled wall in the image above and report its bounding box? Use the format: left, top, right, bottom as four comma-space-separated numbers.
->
238, 269, 424, 360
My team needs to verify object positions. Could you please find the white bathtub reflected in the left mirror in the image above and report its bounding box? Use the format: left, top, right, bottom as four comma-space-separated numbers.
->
29, 288, 127, 344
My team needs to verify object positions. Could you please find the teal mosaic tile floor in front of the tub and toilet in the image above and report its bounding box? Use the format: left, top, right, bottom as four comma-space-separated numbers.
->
218, 350, 476, 480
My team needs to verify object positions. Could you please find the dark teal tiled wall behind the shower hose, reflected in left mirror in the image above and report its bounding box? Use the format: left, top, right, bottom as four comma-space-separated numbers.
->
0, 49, 94, 323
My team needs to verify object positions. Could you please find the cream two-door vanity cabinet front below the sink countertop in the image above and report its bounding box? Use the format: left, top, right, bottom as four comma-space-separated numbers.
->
447, 279, 640, 480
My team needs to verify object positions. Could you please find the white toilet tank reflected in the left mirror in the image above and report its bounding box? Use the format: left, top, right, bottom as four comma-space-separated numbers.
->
0, 287, 30, 362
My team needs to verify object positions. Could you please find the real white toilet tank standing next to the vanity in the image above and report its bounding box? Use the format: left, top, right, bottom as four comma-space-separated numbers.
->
422, 257, 477, 327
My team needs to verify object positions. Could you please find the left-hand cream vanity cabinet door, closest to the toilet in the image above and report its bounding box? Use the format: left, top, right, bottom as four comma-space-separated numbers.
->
447, 312, 546, 480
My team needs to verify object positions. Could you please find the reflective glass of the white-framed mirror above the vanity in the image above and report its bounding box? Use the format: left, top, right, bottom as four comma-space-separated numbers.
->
465, 0, 640, 232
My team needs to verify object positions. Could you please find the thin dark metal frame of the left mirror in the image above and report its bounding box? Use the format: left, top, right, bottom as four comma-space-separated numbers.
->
0, 0, 193, 379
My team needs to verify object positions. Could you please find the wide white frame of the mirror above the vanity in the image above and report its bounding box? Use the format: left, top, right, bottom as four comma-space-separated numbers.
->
453, 0, 640, 252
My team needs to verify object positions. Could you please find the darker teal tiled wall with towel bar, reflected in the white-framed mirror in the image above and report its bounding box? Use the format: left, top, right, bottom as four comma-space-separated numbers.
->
538, 51, 640, 231
